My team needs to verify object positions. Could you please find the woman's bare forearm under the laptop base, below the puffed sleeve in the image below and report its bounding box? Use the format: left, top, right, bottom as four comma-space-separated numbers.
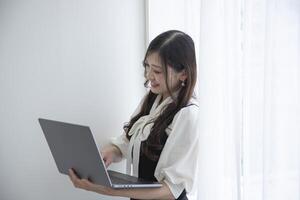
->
112, 183, 175, 199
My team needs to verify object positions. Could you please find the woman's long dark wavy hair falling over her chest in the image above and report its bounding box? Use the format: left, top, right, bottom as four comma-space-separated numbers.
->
123, 30, 197, 161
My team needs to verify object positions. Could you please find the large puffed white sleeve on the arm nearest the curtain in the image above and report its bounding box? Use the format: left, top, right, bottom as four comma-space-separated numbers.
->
154, 105, 199, 198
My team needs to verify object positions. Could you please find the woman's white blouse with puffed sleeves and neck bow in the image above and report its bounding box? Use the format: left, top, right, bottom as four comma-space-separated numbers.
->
111, 92, 199, 198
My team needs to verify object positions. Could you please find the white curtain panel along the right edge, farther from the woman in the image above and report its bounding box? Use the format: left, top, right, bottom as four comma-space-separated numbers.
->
242, 0, 300, 200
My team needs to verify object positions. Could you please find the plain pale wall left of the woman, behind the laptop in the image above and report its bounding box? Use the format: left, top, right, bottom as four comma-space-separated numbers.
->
0, 0, 145, 200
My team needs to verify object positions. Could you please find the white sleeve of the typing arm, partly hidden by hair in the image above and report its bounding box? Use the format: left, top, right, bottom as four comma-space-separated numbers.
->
110, 94, 147, 158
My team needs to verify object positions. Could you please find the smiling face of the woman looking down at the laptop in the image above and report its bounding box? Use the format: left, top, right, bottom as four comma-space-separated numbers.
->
145, 52, 186, 99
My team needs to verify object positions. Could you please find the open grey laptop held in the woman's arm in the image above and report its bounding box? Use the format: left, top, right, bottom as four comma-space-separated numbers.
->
38, 118, 162, 189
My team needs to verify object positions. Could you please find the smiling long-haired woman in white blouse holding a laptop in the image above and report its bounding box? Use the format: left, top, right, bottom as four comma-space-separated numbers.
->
70, 30, 199, 200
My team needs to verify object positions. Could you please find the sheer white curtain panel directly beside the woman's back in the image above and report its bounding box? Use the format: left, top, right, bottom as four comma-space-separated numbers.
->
196, 0, 242, 200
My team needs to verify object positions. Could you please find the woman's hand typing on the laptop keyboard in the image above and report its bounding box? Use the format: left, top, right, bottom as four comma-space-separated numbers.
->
100, 144, 122, 167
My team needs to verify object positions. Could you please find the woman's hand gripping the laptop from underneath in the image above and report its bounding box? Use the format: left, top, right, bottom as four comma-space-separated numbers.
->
69, 169, 116, 196
